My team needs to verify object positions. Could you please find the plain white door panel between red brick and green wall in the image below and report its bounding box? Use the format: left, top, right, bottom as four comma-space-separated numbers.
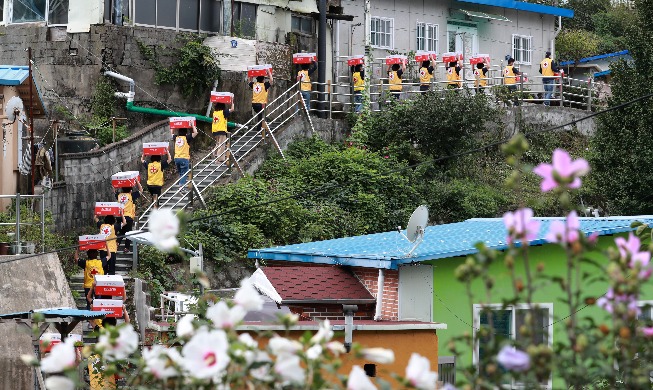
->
399, 264, 433, 322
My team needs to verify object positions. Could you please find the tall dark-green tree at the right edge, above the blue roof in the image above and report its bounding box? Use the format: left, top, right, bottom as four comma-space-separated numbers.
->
590, 0, 653, 215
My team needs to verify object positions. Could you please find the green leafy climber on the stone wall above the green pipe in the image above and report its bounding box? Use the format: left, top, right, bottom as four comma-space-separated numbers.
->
138, 34, 220, 97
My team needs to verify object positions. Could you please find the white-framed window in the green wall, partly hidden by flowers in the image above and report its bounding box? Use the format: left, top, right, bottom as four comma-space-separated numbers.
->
474, 303, 553, 388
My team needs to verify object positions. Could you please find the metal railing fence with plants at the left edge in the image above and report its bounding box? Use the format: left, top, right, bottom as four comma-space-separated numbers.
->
0, 193, 45, 255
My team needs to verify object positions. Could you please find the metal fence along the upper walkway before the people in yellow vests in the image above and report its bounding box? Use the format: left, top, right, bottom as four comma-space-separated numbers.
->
310, 57, 603, 118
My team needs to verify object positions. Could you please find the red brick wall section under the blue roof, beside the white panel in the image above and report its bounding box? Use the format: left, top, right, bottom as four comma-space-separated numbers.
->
353, 268, 399, 321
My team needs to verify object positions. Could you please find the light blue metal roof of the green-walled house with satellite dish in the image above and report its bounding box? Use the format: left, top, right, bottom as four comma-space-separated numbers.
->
247, 216, 653, 269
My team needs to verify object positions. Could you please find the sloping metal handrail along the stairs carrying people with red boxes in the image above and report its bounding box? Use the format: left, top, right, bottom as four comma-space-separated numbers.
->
141, 81, 300, 224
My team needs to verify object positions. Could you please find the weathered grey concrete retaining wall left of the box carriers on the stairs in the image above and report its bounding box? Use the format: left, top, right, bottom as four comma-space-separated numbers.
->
45, 119, 170, 230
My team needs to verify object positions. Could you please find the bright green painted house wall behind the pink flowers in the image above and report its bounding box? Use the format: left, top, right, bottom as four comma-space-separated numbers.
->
427, 235, 653, 388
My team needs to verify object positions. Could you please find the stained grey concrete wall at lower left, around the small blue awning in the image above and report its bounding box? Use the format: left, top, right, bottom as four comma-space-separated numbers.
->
0, 254, 77, 389
